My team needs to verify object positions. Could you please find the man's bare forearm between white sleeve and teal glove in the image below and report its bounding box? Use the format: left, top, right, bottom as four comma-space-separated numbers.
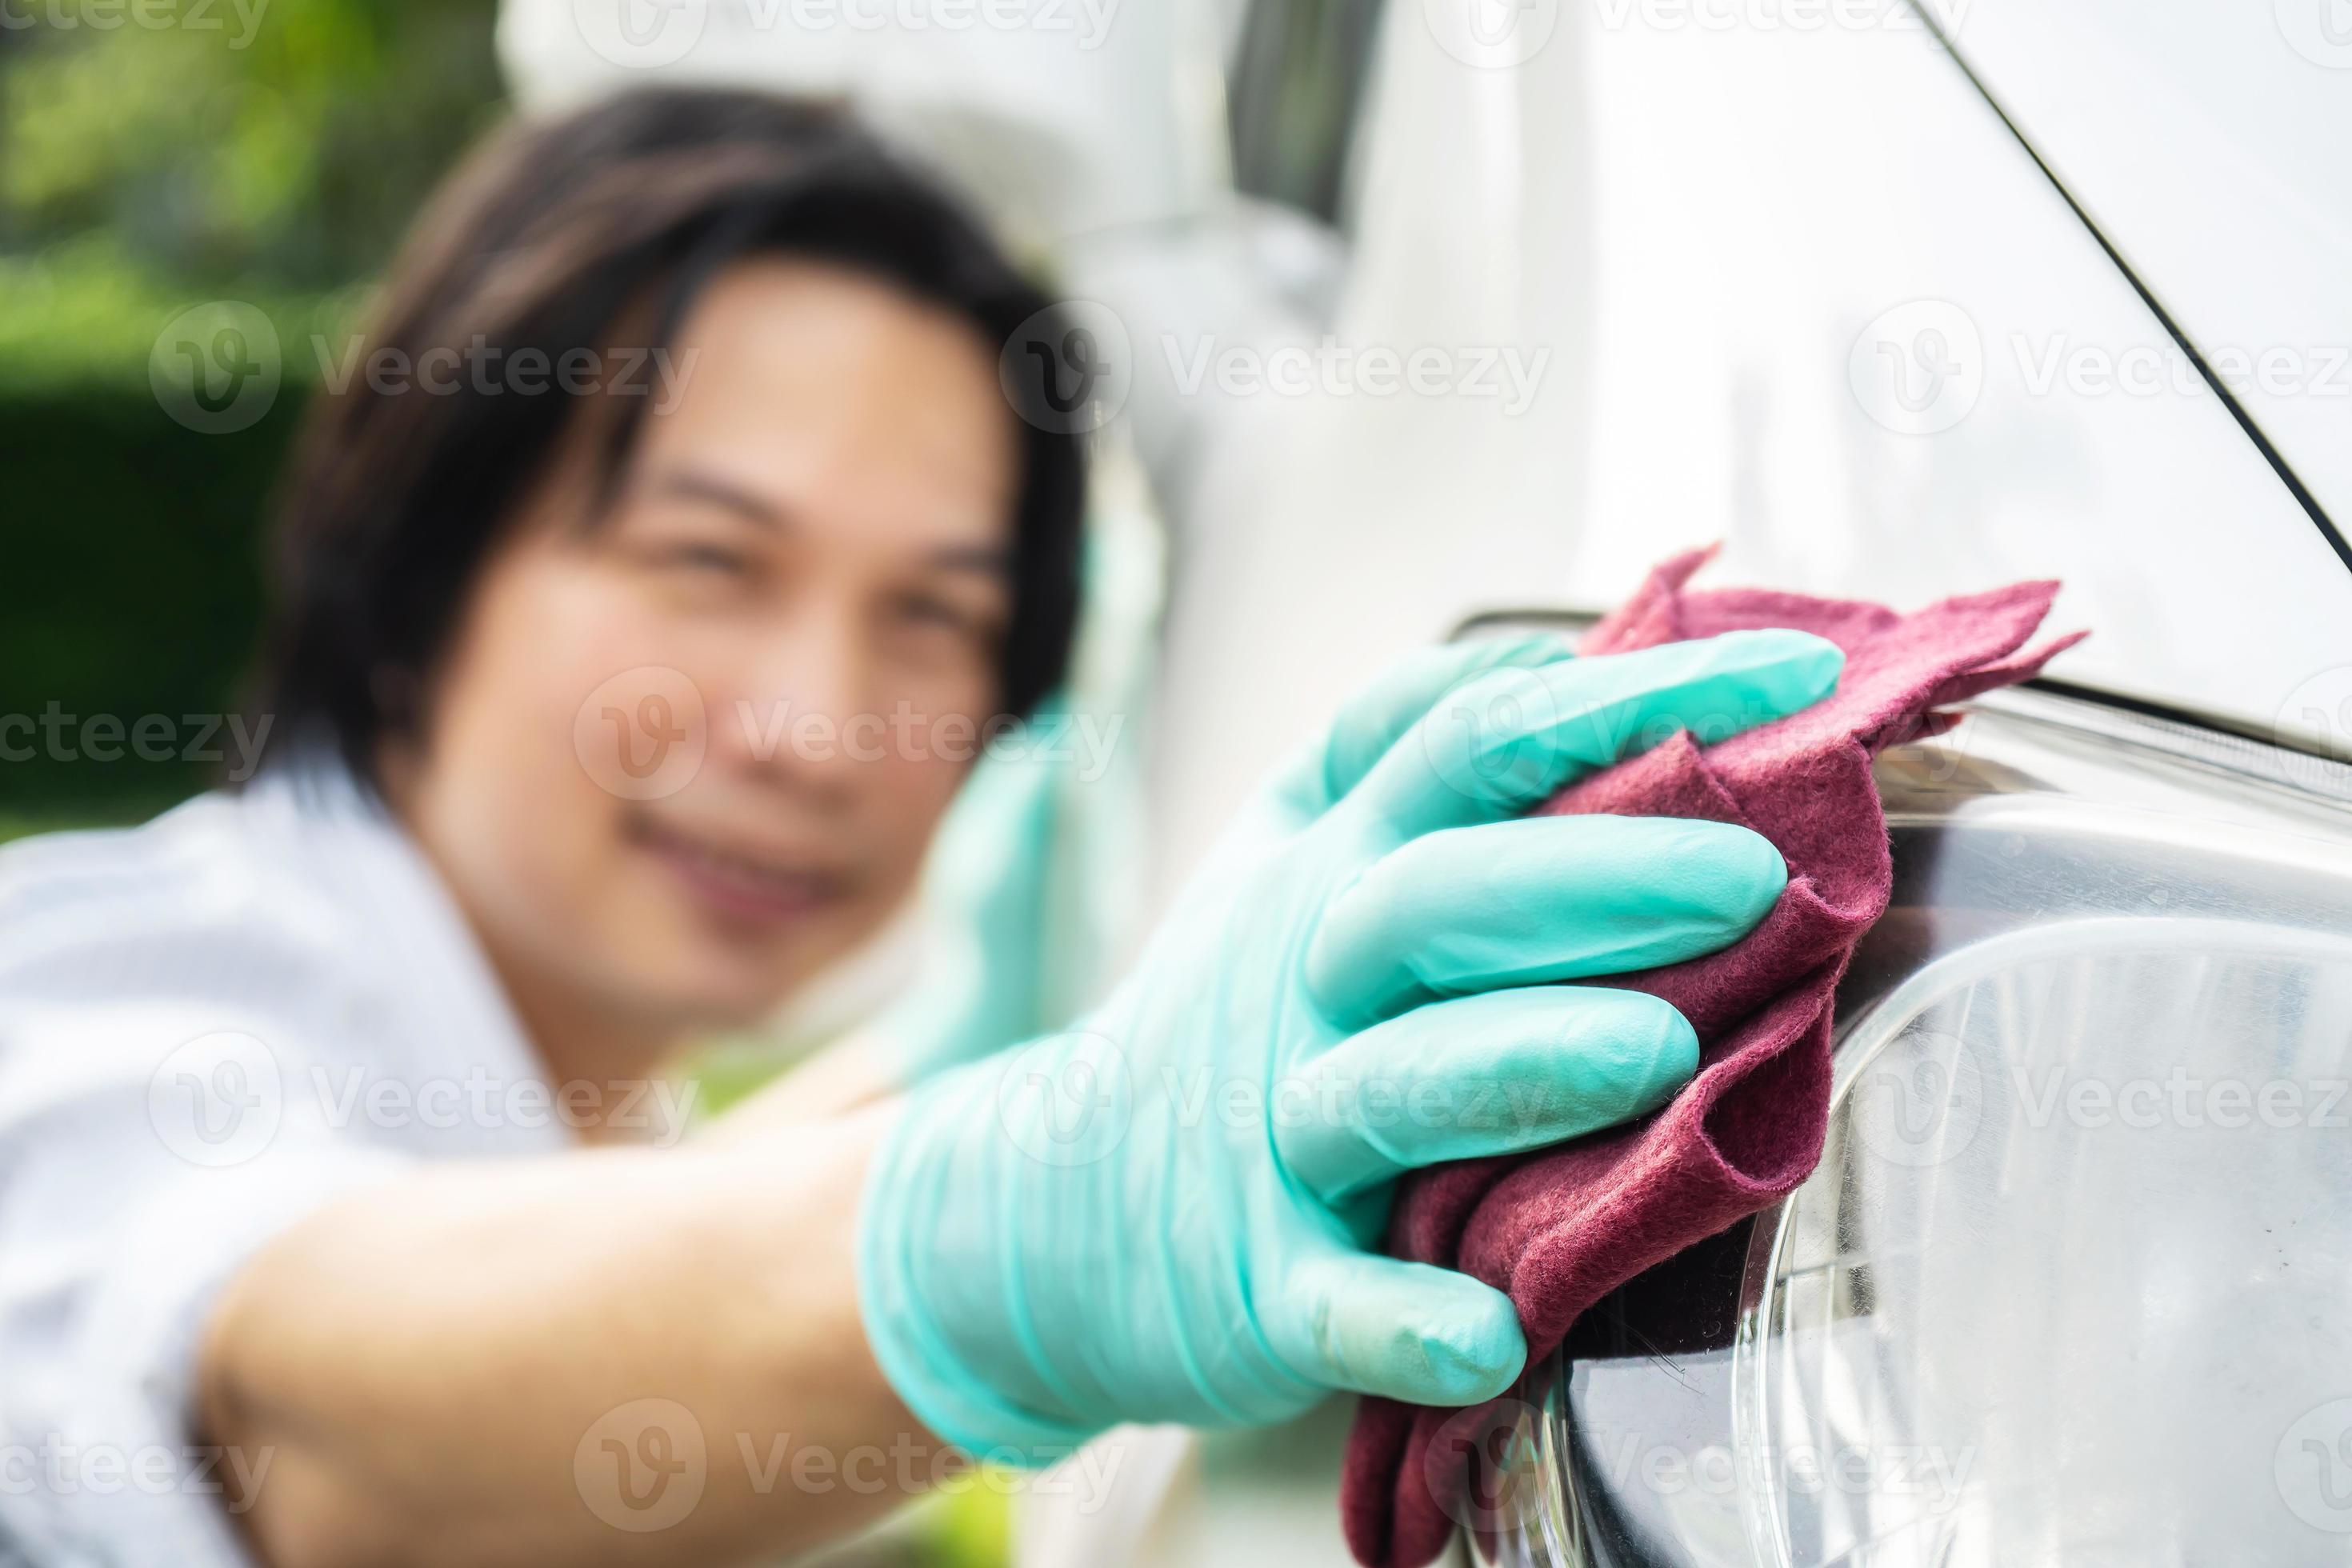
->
200, 1107, 943, 1568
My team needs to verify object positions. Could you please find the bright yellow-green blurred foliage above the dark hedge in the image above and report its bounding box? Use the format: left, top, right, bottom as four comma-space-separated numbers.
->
0, 0, 498, 291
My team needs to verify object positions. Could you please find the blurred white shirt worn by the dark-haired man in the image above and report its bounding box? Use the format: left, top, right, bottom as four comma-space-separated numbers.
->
0, 766, 571, 1568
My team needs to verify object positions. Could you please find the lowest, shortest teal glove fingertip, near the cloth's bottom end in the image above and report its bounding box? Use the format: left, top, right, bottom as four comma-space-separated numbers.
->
1263, 1248, 1526, 1406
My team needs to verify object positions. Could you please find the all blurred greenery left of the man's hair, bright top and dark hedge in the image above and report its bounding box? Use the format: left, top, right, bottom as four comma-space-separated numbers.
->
0, 0, 501, 834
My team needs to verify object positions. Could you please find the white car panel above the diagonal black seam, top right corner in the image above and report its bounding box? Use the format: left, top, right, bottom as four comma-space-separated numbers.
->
1952, 0, 2352, 529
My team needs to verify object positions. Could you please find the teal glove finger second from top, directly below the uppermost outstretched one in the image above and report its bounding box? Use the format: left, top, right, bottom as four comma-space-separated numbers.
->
1306, 816, 1787, 1027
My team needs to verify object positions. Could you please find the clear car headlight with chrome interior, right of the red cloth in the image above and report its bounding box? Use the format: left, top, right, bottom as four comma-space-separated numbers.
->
1472, 694, 2352, 1568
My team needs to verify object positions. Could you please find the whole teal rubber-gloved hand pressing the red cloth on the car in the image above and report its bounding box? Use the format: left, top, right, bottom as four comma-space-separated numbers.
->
858, 632, 1844, 1460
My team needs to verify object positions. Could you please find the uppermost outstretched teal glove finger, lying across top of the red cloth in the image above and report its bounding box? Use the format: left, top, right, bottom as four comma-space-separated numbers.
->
1346, 630, 1846, 837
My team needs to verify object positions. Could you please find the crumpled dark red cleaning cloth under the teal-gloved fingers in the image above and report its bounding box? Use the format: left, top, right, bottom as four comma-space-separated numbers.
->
1341, 550, 2082, 1568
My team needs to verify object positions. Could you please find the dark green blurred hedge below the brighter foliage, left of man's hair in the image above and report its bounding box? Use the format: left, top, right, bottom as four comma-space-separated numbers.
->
0, 376, 303, 830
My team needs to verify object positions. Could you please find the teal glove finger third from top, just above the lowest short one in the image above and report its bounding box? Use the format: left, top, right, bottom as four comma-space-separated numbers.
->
1274, 985, 1698, 1206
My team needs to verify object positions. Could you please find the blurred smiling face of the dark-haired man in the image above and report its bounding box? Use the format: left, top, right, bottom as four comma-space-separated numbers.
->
386, 261, 1018, 1062
